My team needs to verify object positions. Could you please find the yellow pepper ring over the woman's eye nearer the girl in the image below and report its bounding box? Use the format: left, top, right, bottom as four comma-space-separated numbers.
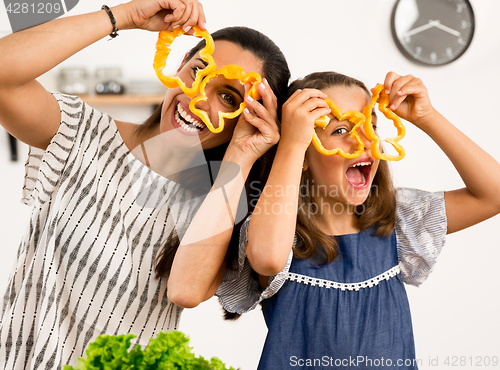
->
189, 64, 262, 134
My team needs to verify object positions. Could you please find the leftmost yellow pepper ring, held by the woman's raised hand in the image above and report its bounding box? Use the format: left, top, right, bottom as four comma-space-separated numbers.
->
153, 26, 216, 98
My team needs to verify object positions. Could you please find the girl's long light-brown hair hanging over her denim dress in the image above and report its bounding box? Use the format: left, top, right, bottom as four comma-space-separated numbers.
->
288, 72, 396, 263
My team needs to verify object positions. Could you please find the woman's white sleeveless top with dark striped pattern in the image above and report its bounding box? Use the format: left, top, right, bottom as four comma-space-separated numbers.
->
0, 94, 199, 370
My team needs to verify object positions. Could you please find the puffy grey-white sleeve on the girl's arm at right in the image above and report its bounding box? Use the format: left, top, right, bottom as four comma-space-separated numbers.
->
396, 188, 447, 286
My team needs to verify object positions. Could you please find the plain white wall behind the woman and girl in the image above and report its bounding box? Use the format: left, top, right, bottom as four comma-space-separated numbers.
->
0, 0, 500, 370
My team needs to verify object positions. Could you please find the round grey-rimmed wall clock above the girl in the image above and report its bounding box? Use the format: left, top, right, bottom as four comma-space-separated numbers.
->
391, 0, 474, 66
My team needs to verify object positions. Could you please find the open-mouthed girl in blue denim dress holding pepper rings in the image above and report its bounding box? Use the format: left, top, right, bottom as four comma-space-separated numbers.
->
219, 72, 500, 370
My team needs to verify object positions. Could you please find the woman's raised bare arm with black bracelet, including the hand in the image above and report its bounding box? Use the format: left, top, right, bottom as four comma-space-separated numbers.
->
0, 0, 205, 149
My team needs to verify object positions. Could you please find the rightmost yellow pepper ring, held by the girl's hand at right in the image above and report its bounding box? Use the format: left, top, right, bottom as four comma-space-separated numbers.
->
363, 84, 406, 161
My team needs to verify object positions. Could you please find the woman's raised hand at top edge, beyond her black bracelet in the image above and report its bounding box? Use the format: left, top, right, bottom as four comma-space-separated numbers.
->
113, 0, 206, 33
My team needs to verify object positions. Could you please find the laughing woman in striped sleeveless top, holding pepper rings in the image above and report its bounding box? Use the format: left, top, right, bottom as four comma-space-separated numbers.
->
0, 0, 289, 369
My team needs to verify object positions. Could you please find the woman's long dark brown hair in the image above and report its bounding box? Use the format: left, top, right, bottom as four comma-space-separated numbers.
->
145, 27, 290, 277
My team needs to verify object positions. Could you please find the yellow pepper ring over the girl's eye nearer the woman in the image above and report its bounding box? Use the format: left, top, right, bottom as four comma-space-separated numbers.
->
312, 98, 365, 159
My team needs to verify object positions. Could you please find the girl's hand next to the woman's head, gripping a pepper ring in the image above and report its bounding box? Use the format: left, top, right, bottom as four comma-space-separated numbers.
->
280, 89, 330, 151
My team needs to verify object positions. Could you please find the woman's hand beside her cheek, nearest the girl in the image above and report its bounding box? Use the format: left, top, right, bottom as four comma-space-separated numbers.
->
228, 79, 280, 163
